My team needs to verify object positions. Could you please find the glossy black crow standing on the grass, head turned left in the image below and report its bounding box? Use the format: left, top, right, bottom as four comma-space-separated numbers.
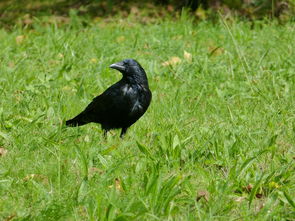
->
66, 59, 152, 137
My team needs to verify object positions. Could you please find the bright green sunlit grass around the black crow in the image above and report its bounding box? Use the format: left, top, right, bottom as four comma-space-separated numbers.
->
0, 15, 295, 220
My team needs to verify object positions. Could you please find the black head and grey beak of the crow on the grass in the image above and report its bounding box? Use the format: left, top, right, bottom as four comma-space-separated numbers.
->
110, 59, 147, 81
